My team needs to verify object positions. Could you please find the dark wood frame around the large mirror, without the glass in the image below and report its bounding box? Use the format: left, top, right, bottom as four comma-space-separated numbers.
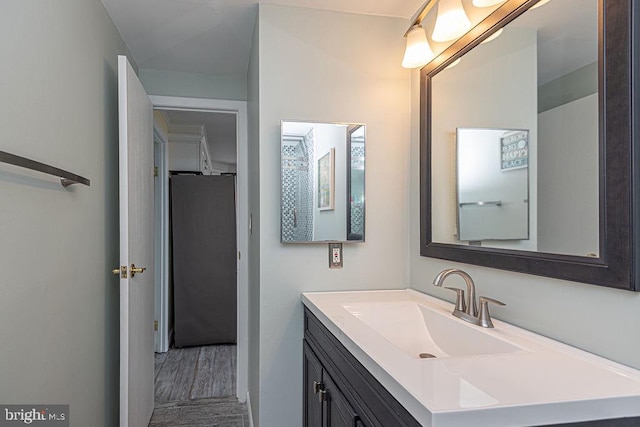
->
420, 0, 640, 291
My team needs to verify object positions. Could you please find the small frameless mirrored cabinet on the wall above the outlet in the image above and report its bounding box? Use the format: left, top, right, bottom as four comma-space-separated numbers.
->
280, 120, 365, 243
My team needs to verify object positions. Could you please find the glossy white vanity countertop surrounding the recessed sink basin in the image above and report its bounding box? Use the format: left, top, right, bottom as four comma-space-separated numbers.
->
302, 289, 640, 427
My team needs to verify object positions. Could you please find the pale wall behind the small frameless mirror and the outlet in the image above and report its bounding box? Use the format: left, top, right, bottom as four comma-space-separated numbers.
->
250, 4, 410, 427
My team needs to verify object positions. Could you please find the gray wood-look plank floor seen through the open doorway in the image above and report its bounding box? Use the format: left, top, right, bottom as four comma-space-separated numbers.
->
149, 345, 249, 427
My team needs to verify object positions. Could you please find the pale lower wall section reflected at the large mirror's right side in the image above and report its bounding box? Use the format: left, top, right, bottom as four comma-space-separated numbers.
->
538, 93, 600, 256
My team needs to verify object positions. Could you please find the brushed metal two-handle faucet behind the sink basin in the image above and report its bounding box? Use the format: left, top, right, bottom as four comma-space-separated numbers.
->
433, 268, 505, 328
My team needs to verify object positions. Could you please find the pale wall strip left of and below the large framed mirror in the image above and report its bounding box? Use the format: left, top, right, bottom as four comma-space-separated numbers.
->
408, 72, 640, 368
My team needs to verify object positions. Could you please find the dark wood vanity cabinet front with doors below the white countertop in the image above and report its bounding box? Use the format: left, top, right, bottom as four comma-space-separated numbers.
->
303, 308, 420, 427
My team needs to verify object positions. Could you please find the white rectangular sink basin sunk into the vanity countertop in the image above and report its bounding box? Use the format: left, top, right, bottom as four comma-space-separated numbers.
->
342, 301, 523, 360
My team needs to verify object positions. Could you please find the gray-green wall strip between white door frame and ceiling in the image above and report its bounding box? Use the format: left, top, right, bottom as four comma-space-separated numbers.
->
139, 69, 247, 101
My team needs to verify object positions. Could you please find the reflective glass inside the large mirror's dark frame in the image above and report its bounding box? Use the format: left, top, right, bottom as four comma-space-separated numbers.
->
430, 0, 600, 257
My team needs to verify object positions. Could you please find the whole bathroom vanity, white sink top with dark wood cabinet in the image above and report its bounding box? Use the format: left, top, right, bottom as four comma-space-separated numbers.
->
302, 289, 640, 427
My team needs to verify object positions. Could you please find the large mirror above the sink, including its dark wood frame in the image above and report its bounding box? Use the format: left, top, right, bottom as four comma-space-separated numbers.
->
421, 0, 640, 290
